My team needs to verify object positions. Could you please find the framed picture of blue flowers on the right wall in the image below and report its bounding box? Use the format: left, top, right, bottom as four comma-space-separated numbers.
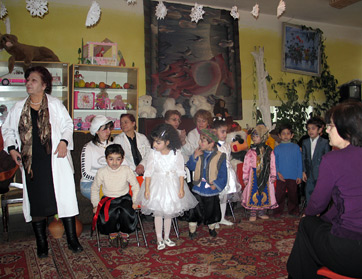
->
282, 22, 321, 76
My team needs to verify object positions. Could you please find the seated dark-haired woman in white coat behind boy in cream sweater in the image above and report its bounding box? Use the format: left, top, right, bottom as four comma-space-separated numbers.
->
114, 113, 151, 175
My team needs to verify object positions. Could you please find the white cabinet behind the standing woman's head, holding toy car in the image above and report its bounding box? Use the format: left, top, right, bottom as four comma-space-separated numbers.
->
0, 61, 69, 126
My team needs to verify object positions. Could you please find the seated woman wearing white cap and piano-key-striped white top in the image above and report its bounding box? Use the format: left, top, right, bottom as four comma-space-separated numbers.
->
80, 115, 113, 200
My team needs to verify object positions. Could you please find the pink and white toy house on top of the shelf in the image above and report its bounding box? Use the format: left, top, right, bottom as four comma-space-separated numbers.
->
83, 42, 118, 66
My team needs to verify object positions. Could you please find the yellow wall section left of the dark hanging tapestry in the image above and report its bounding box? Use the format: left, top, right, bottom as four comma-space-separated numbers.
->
0, 1, 146, 95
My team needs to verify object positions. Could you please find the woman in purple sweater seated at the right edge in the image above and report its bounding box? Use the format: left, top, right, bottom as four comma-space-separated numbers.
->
287, 102, 362, 279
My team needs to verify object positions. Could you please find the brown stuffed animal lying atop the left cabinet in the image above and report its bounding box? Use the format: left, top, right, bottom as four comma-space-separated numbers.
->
0, 34, 59, 73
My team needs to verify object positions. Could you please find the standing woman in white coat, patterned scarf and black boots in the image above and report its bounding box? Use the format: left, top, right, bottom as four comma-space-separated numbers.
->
2, 66, 83, 258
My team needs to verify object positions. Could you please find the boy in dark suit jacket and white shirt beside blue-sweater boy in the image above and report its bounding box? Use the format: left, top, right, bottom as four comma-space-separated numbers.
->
302, 117, 330, 202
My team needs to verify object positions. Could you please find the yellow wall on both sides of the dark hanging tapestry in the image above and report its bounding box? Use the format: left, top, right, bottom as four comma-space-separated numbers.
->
0, 0, 362, 126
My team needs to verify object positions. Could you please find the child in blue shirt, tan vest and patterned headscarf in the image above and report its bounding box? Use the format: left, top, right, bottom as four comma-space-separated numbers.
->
187, 129, 228, 239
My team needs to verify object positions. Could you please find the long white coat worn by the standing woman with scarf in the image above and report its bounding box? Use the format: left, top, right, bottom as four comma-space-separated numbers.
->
1, 94, 79, 222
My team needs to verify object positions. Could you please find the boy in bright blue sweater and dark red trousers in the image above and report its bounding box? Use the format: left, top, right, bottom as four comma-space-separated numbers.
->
274, 124, 303, 217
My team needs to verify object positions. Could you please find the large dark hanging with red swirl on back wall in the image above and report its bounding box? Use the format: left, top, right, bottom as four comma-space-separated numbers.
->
144, 0, 242, 119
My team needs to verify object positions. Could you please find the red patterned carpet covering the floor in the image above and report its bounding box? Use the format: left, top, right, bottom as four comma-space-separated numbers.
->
0, 212, 299, 279
